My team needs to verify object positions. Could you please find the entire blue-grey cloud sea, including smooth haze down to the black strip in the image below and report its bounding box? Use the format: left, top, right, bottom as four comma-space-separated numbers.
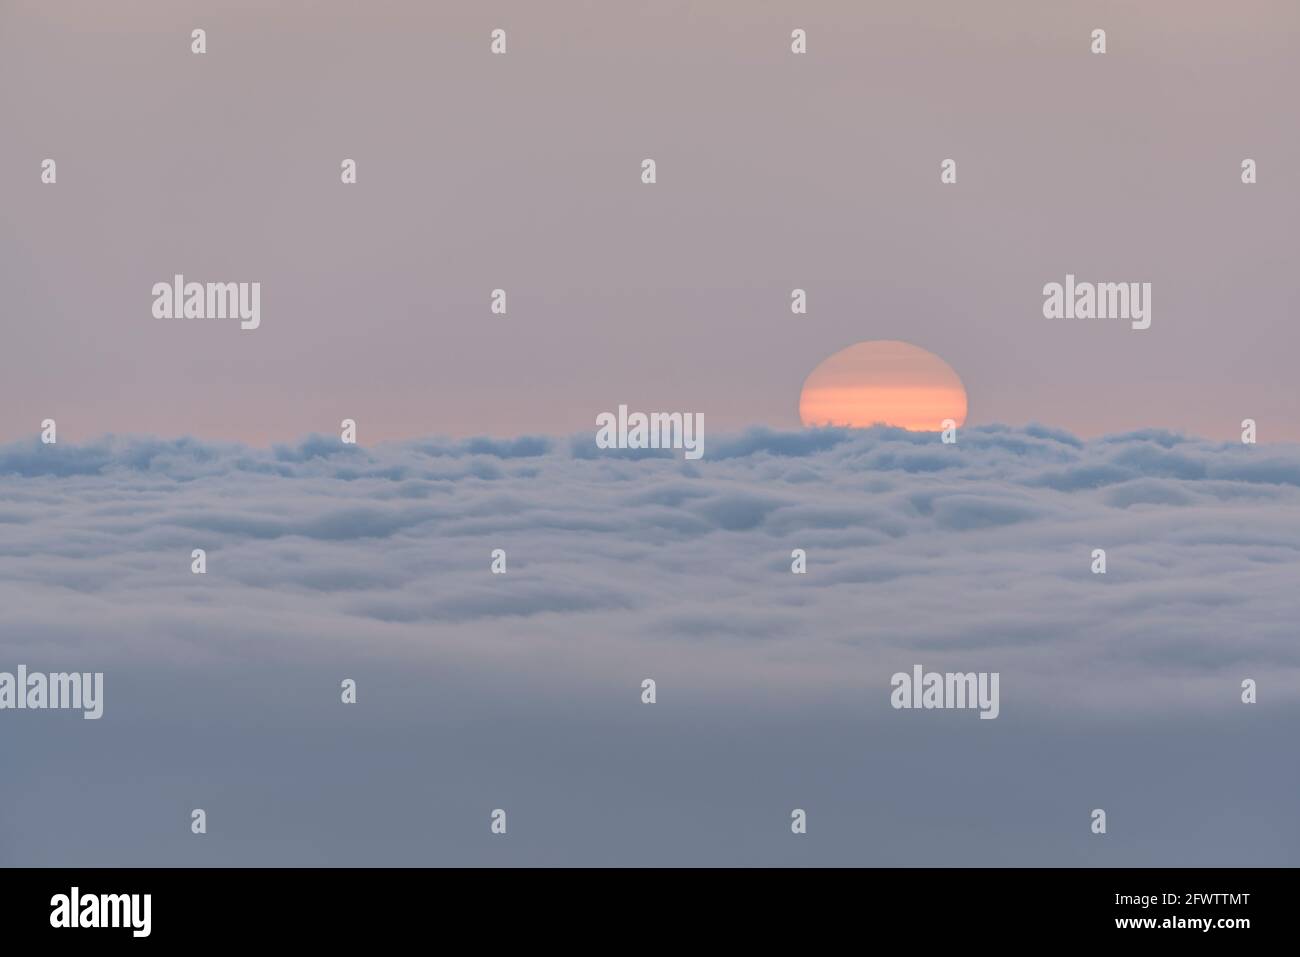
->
0, 426, 1300, 863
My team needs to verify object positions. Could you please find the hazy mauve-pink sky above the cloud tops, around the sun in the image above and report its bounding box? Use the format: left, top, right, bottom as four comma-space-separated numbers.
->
0, 0, 1300, 443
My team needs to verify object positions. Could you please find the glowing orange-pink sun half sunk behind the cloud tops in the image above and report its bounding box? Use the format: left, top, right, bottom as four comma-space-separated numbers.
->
800, 339, 966, 432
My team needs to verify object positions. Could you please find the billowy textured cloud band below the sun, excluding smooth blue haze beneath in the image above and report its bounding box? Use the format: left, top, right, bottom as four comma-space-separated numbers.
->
0, 426, 1300, 713
